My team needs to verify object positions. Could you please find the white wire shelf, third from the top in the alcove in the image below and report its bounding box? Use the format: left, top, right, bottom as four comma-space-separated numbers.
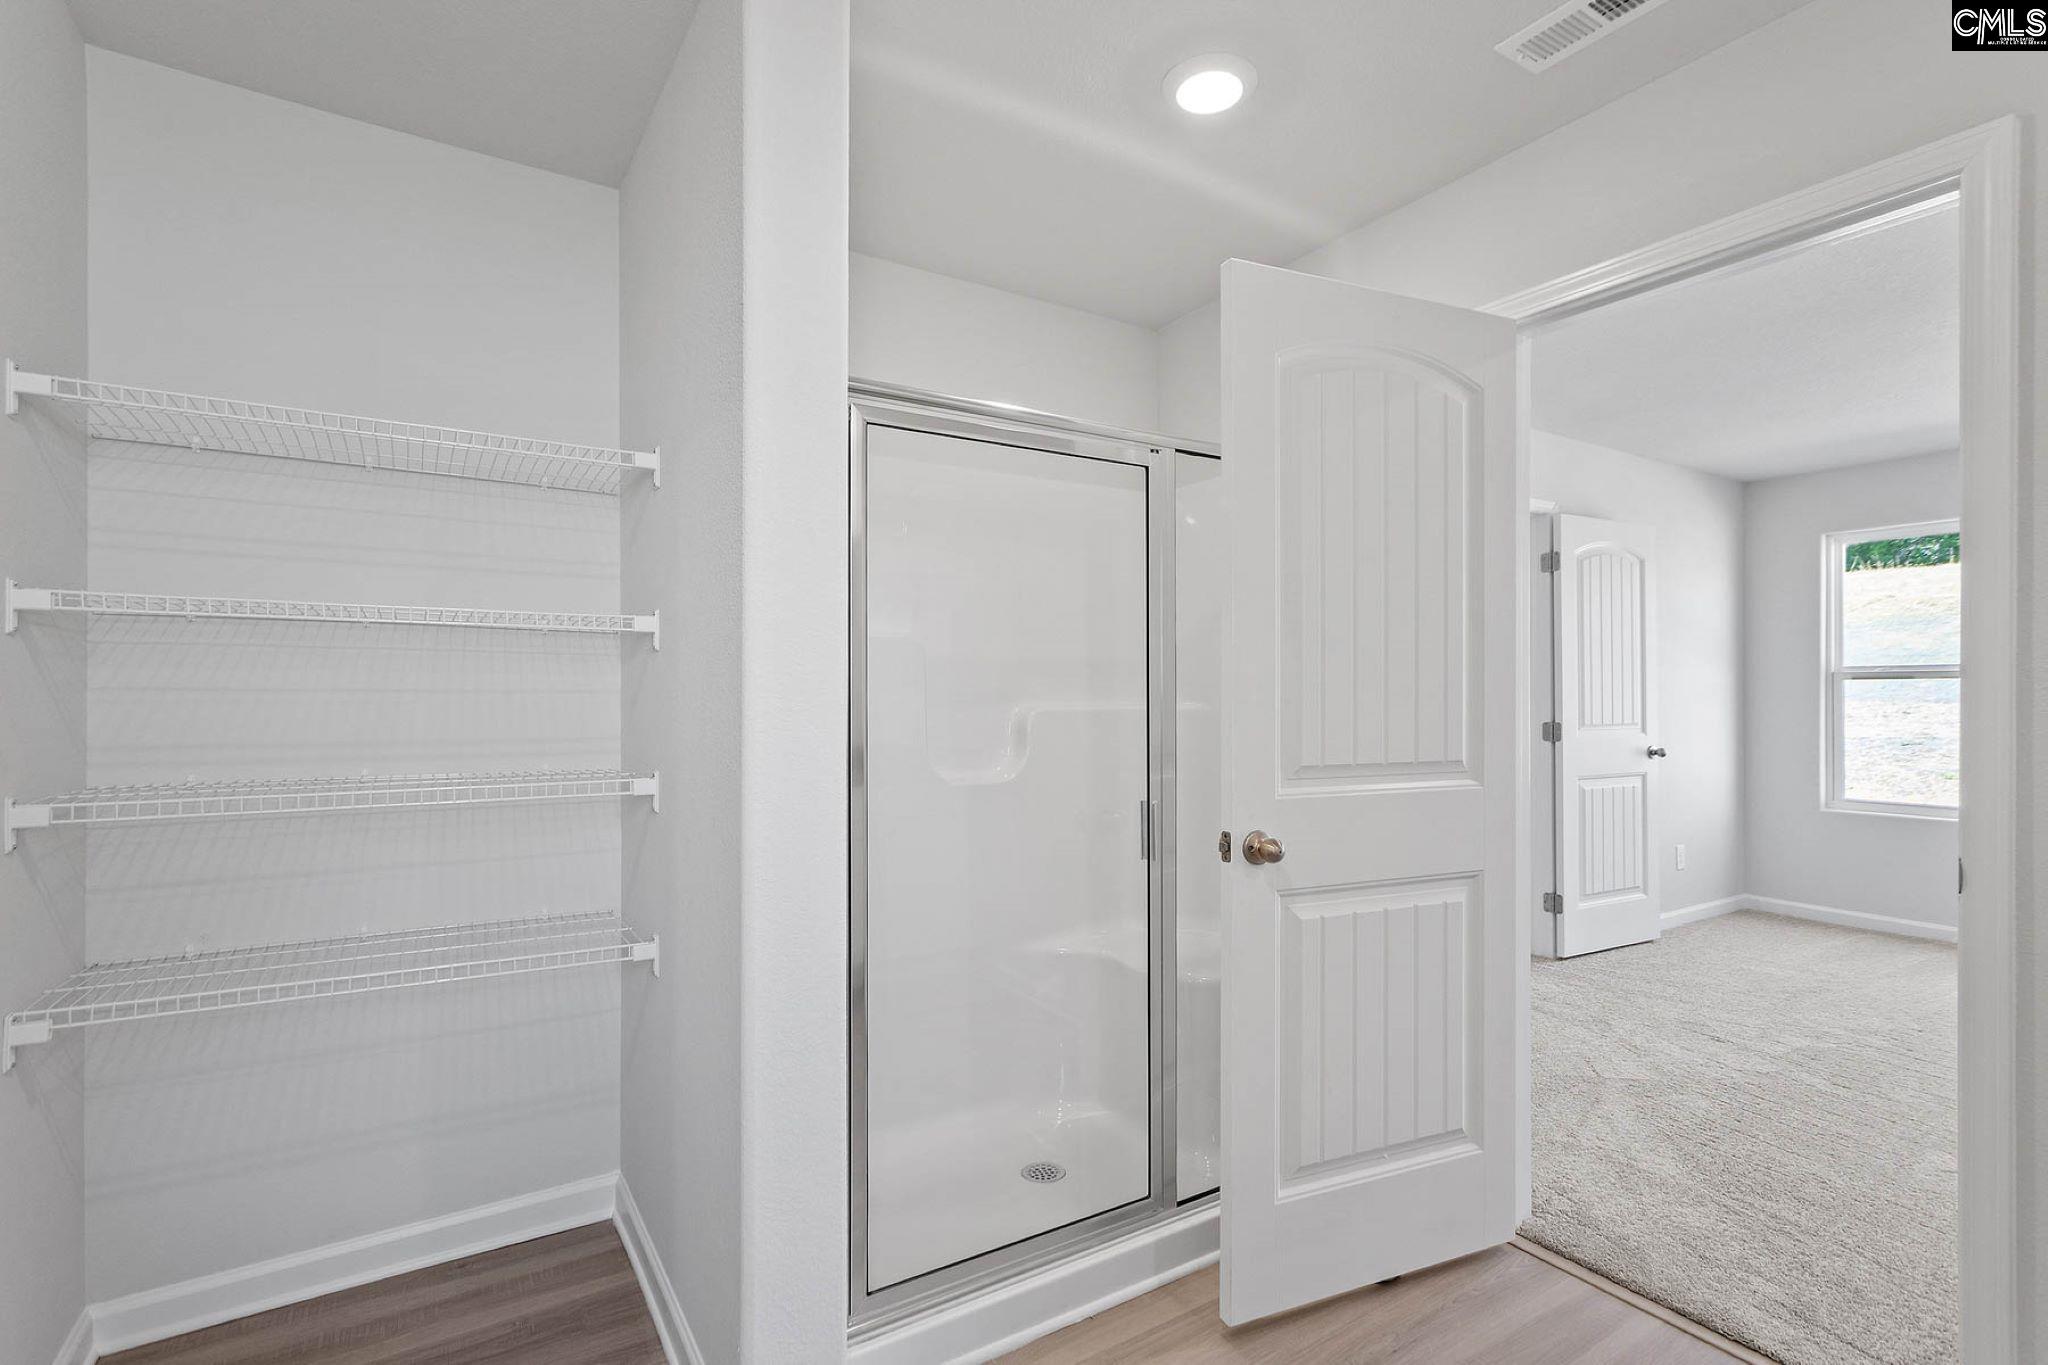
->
0, 767, 662, 853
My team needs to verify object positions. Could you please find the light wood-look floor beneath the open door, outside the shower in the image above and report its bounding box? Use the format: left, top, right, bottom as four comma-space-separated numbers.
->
1004, 1246, 1737, 1365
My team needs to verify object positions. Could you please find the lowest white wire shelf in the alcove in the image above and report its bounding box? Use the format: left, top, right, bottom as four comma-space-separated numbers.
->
0, 911, 662, 1072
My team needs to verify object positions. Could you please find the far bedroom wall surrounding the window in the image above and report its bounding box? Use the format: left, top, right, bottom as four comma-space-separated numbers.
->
1743, 452, 1962, 927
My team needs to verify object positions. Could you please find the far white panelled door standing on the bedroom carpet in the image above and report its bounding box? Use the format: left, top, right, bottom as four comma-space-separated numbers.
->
1552, 516, 1663, 958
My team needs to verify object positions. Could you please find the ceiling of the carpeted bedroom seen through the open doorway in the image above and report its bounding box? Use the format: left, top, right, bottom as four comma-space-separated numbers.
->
1530, 205, 1960, 479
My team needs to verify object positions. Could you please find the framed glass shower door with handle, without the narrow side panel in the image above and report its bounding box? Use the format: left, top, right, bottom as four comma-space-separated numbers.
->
854, 417, 1155, 1308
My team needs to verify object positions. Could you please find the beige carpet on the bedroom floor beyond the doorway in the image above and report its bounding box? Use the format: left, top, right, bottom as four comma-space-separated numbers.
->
1522, 911, 1958, 1365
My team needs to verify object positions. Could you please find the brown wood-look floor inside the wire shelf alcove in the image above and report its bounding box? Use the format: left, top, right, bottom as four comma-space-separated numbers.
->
100, 1224, 664, 1365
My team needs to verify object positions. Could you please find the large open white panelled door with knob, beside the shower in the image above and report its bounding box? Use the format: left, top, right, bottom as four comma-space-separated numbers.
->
1223, 262, 1528, 1322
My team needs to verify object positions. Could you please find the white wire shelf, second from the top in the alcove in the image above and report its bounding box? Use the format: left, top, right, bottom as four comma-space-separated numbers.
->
6, 579, 662, 649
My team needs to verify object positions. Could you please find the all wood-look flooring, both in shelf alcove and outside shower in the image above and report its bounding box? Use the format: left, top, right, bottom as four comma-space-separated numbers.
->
102, 1224, 1755, 1365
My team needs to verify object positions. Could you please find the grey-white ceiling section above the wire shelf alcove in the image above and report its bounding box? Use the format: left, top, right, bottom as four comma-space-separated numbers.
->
70, 0, 696, 184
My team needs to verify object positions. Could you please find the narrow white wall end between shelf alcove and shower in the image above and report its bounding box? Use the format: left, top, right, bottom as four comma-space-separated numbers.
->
739, 0, 852, 1363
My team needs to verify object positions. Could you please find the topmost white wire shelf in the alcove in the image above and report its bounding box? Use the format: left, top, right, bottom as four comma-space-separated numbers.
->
6, 360, 662, 493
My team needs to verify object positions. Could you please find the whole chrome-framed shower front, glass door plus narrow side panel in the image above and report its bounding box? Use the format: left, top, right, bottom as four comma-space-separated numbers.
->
852, 389, 1223, 1357
